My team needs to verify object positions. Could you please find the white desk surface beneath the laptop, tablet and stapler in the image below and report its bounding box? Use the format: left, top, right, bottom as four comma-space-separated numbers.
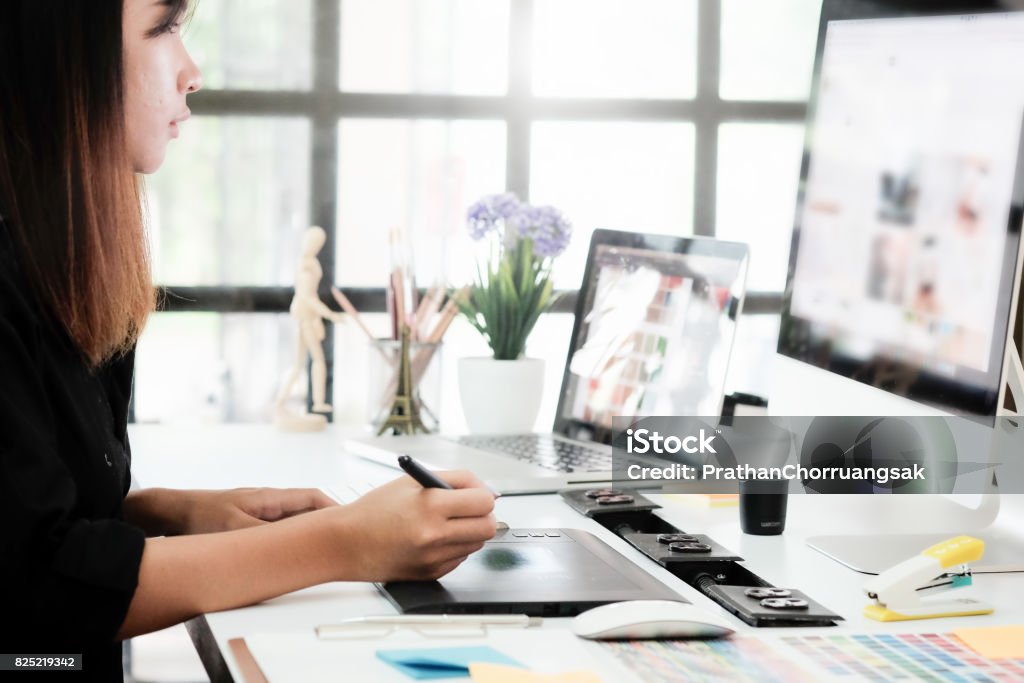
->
129, 425, 1024, 681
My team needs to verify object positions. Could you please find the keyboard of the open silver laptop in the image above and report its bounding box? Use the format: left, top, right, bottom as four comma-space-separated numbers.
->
452, 434, 611, 472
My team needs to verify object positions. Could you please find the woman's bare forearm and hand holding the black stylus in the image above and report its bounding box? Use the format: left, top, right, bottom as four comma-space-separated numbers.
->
118, 472, 495, 638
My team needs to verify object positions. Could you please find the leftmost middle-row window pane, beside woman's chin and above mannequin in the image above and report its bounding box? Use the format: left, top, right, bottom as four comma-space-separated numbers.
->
146, 116, 310, 286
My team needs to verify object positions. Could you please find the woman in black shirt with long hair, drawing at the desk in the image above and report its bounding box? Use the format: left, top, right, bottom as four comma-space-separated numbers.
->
0, 0, 495, 680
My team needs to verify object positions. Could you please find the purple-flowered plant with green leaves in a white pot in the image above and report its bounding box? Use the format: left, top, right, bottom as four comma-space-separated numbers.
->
459, 193, 572, 434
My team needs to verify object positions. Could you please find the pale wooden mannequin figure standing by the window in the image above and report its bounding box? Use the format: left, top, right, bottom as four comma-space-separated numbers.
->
273, 225, 342, 431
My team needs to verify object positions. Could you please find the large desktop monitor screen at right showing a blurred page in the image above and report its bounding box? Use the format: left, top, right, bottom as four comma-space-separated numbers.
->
779, 9, 1024, 415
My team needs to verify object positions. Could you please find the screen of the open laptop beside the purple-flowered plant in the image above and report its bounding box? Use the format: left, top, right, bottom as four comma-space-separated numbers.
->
555, 230, 748, 443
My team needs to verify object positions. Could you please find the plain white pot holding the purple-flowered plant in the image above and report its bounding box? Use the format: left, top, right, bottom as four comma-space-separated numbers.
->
459, 357, 544, 434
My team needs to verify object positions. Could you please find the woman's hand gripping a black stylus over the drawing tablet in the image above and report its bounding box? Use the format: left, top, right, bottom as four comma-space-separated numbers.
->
339, 471, 496, 582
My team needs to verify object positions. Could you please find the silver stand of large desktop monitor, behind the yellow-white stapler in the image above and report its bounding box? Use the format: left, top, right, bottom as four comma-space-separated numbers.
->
807, 341, 1024, 574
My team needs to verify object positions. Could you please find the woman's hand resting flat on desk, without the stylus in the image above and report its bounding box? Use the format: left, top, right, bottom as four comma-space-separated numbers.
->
180, 488, 337, 533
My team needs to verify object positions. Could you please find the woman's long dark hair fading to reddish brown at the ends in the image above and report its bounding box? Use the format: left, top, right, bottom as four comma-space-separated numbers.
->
0, 0, 186, 366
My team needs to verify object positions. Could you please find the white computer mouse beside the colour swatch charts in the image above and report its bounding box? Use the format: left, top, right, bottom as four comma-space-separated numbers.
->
572, 600, 735, 640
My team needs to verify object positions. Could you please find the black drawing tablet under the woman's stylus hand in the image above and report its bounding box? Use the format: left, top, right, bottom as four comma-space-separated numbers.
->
377, 528, 686, 616
